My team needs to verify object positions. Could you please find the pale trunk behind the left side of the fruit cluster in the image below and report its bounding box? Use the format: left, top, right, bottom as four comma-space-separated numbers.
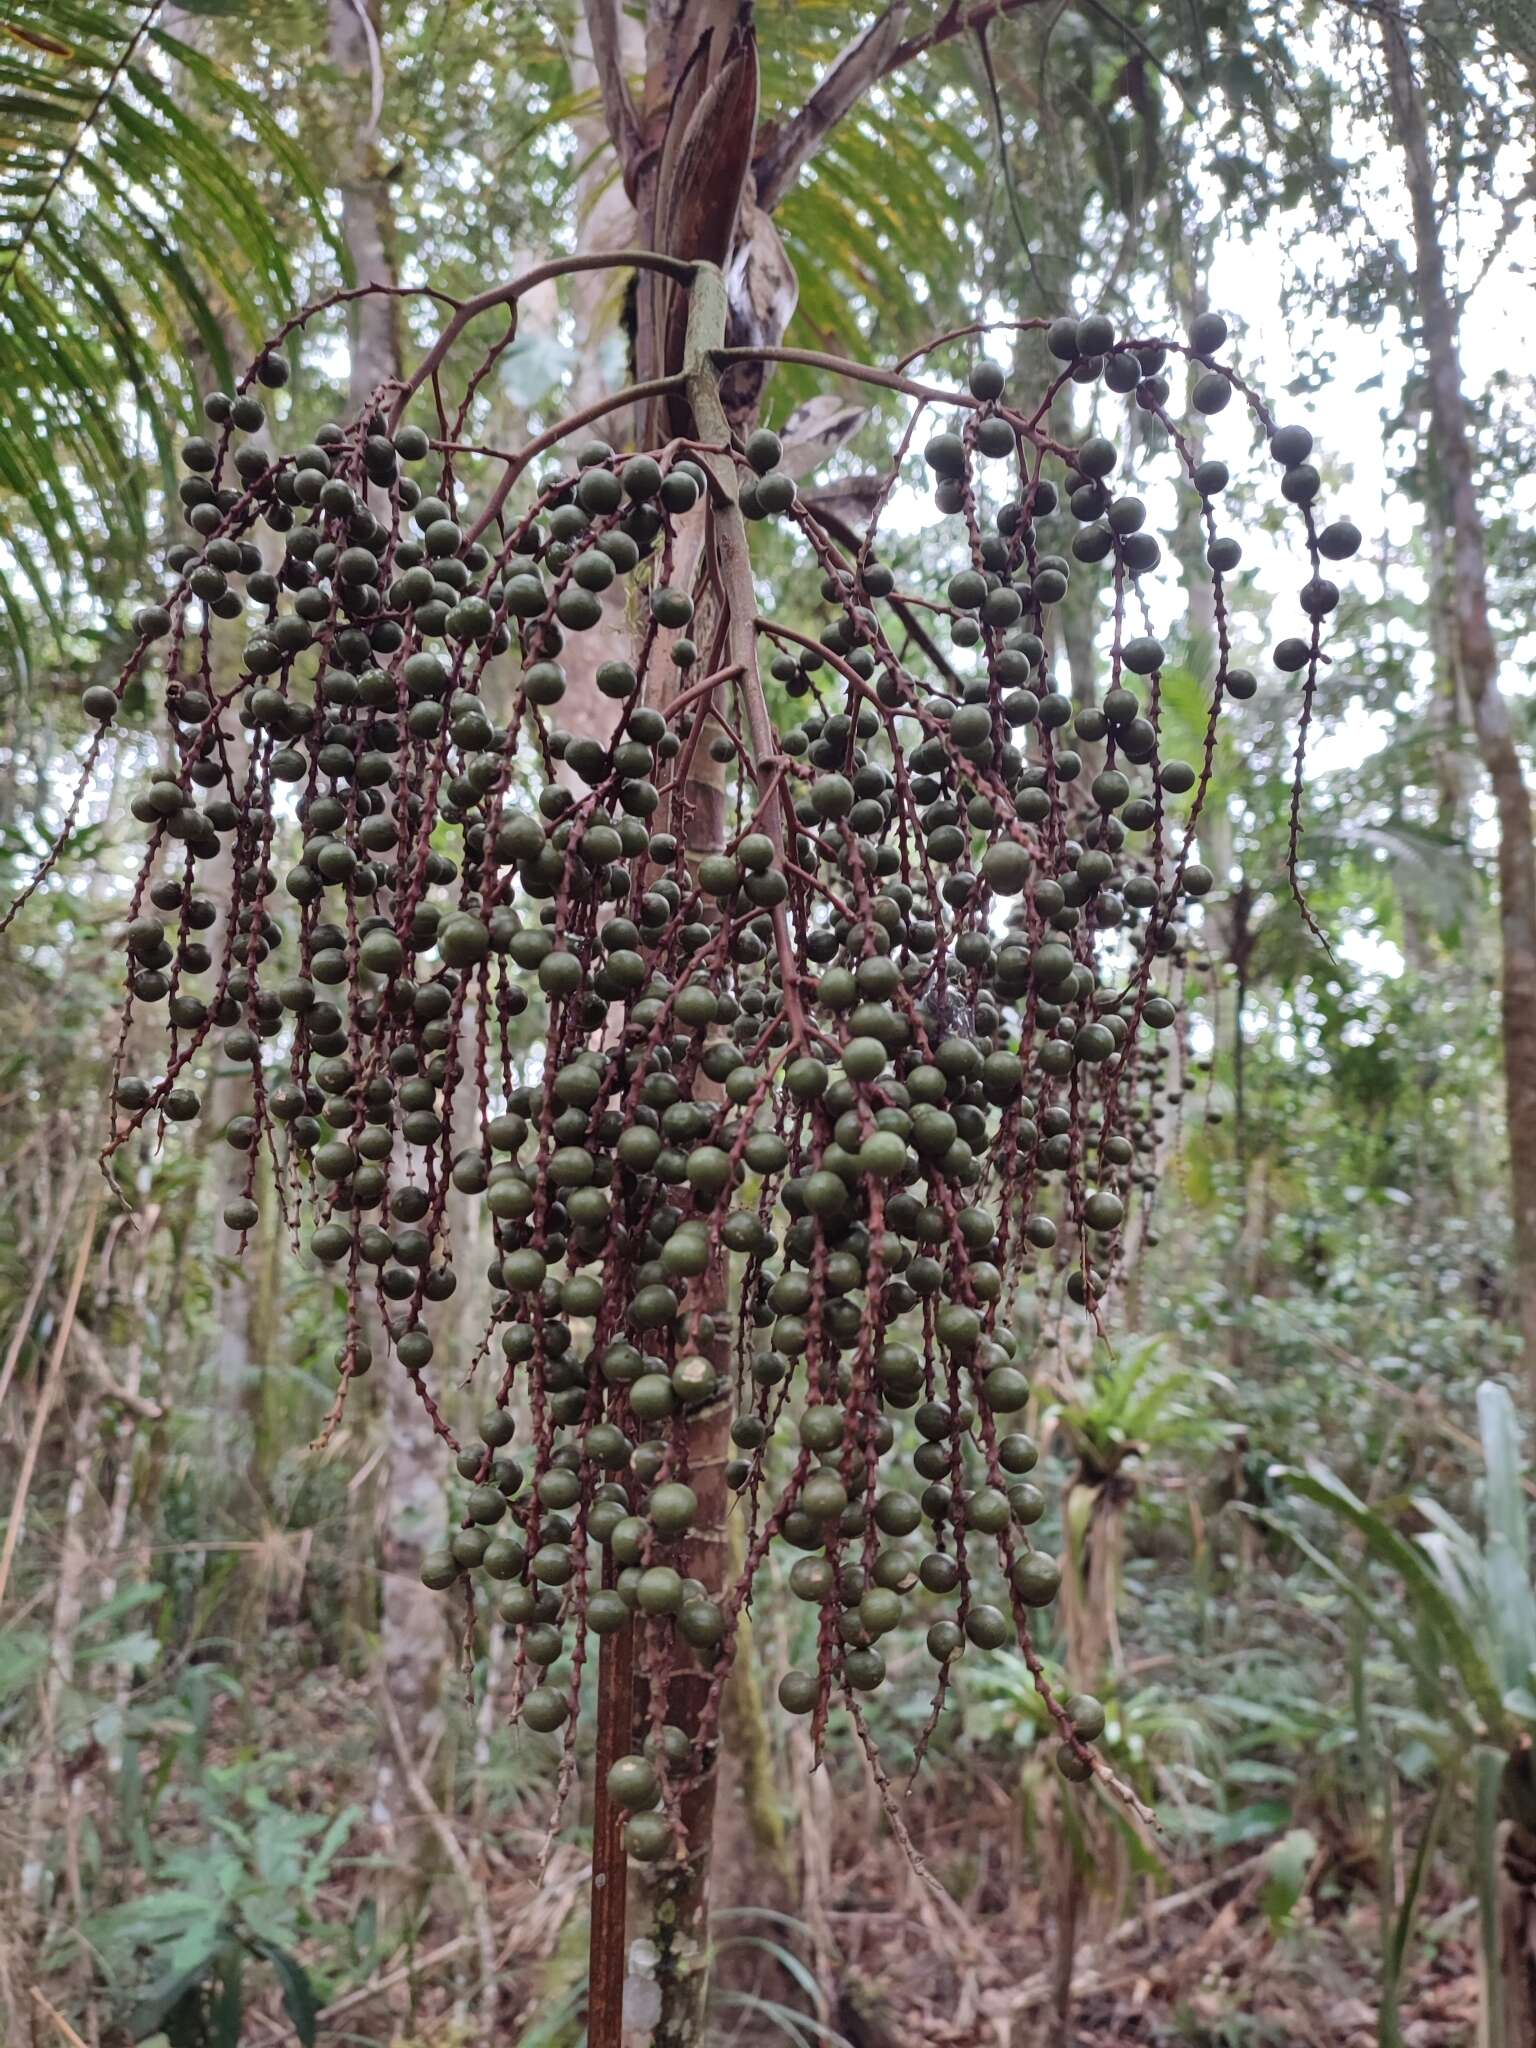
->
328, 0, 453, 1884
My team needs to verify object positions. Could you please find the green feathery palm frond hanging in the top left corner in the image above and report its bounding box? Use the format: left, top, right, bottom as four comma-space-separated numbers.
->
0, 0, 344, 678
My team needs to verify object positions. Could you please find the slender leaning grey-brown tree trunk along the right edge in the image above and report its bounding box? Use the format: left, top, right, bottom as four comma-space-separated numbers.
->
1380, 14, 1536, 1395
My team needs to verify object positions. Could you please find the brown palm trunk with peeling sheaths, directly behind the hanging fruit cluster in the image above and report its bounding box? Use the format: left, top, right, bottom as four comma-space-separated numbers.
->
561, 16, 1040, 2048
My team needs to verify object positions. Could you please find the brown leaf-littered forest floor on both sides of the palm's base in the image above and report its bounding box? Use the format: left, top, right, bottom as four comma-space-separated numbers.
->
36, 1665, 1479, 2048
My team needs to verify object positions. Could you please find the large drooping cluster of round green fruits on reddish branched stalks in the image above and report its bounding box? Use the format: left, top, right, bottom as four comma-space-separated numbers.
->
12, 252, 1358, 1882
